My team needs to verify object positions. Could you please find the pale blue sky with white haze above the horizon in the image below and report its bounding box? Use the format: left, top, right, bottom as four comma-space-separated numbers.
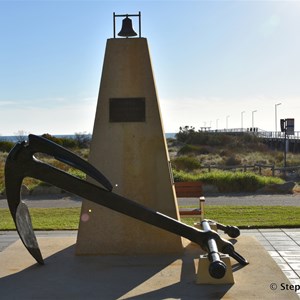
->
0, 0, 300, 136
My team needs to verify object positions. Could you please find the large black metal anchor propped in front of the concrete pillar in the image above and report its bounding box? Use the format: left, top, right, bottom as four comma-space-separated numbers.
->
5, 135, 248, 278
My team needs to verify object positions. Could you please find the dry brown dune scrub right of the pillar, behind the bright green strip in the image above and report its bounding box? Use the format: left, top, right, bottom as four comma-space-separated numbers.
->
168, 126, 300, 175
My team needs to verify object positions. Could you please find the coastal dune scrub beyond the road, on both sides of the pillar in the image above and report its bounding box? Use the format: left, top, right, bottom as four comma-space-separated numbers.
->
0, 127, 300, 193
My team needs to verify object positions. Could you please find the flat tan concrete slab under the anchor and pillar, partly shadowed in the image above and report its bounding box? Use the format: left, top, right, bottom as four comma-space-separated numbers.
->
0, 237, 298, 300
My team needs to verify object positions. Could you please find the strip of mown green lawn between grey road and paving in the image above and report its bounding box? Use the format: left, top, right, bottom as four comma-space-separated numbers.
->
0, 206, 300, 230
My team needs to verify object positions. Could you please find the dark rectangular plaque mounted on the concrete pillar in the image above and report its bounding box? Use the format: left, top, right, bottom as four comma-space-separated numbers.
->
109, 98, 146, 122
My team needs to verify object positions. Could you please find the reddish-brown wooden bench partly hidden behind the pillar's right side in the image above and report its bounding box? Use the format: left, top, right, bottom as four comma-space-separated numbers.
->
175, 181, 205, 220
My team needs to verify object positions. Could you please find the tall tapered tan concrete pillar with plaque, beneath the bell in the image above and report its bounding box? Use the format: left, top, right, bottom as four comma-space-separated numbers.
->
76, 38, 182, 255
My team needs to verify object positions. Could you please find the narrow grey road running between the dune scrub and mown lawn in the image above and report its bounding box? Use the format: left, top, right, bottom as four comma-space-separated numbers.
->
0, 194, 300, 208
